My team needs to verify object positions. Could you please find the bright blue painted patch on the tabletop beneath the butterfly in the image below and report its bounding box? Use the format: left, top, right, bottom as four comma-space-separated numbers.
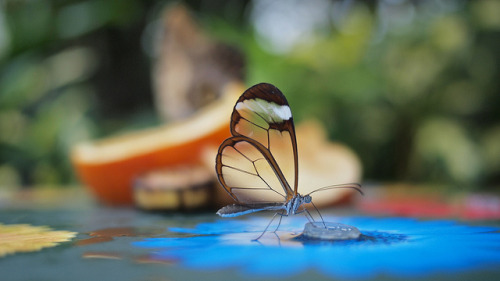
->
134, 217, 500, 278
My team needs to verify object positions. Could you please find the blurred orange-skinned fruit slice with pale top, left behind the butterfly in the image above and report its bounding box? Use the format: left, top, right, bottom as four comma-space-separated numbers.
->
71, 84, 245, 205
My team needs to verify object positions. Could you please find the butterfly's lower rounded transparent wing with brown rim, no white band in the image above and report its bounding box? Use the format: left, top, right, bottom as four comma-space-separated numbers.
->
216, 136, 289, 204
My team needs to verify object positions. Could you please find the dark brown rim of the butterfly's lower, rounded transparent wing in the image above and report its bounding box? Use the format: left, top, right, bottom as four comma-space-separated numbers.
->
215, 136, 294, 202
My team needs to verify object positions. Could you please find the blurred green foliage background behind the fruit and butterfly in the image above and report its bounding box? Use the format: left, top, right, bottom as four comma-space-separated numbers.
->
0, 0, 500, 190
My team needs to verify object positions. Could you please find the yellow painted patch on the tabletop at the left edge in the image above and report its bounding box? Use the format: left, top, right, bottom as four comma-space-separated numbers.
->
0, 223, 77, 257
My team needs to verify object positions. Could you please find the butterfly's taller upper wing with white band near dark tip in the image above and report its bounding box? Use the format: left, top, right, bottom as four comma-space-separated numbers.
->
231, 83, 298, 199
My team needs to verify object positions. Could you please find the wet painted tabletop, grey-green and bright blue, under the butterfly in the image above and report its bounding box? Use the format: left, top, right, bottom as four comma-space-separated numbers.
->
0, 189, 500, 280
